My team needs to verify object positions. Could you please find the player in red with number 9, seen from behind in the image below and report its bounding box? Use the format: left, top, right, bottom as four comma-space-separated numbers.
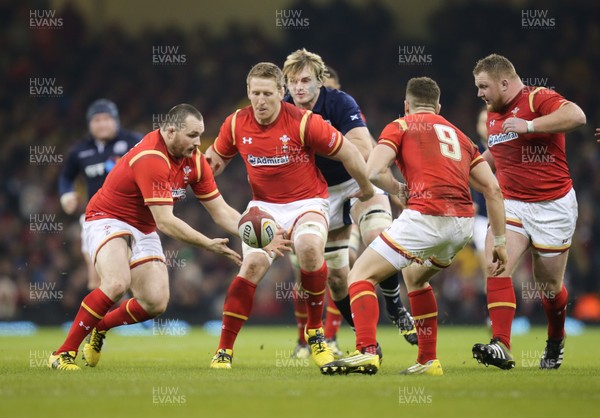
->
321, 77, 507, 376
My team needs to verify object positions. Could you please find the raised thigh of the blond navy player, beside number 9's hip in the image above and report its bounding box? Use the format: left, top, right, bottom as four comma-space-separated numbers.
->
351, 194, 393, 246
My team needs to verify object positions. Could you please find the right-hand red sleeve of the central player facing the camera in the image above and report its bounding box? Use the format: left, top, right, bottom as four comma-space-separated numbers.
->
300, 111, 344, 156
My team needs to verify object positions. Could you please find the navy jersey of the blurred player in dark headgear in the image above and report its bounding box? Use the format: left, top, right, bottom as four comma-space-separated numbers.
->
58, 129, 142, 197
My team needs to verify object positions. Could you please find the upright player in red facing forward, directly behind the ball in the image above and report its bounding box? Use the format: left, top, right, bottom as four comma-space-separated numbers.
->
207, 63, 373, 369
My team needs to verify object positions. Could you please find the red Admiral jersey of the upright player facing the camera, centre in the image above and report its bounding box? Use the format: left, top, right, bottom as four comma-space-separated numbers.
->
214, 102, 344, 203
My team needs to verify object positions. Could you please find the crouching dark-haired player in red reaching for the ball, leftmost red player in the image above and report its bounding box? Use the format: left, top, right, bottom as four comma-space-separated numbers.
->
48, 104, 272, 370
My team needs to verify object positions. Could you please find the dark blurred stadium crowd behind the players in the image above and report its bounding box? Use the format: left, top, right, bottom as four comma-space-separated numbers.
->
0, 0, 600, 324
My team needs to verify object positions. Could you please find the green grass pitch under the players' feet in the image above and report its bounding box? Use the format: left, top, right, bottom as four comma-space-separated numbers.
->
0, 325, 600, 418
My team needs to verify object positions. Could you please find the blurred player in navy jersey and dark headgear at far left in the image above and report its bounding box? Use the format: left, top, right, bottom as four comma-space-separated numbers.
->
58, 99, 142, 290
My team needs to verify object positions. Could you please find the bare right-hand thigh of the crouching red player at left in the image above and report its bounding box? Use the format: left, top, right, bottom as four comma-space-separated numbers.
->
131, 260, 169, 306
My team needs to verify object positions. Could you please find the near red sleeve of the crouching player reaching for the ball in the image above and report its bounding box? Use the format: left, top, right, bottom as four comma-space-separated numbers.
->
129, 150, 173, 206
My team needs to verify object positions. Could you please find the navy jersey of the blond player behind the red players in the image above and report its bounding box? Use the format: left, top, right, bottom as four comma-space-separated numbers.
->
283, 87, 367, 186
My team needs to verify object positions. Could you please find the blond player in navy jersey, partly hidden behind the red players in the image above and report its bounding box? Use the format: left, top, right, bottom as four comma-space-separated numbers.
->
283, 49, 417, 357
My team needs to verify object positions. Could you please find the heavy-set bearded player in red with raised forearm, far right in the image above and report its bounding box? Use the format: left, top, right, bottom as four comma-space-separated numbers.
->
473, 54, 585, 369
